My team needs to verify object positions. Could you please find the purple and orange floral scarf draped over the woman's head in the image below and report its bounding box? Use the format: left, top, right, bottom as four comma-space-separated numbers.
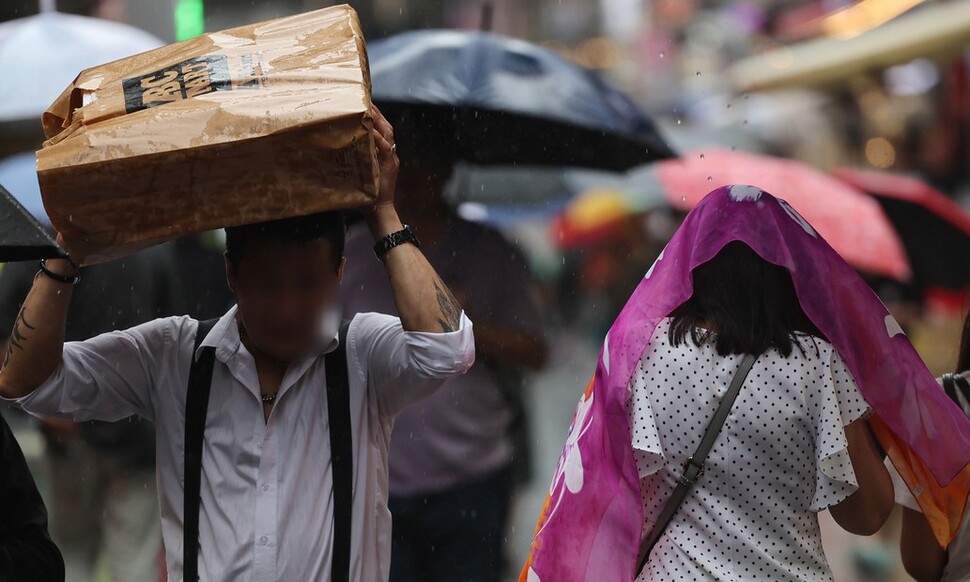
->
519, 186, 970, 582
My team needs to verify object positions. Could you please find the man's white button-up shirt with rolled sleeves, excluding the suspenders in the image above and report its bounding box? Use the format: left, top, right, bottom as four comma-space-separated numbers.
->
6, 308, 475, 582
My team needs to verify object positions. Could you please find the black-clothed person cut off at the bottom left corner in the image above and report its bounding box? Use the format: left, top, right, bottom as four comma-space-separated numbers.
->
0, 410, 64, 582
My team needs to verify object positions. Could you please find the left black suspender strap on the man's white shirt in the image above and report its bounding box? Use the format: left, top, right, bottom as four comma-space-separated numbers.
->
182, 319, 219, 582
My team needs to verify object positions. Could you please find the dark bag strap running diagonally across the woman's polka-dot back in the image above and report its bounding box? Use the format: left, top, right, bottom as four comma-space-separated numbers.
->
637, 354, 758, 576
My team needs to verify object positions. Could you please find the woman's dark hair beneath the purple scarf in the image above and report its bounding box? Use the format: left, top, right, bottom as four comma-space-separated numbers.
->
670, 242, 823, 357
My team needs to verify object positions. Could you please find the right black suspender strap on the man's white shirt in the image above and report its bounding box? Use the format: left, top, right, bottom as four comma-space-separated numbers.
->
324, 321, 354, 582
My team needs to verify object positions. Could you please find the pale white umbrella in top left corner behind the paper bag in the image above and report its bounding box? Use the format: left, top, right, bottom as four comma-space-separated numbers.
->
0, 12, 164, 122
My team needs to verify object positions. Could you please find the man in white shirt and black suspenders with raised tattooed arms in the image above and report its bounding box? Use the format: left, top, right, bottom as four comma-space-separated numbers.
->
0, 111, 474, 582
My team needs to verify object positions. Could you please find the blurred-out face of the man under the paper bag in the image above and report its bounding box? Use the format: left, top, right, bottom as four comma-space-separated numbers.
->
226, 239, 343, 362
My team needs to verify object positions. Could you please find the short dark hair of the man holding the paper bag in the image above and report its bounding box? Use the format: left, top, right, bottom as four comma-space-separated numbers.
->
226, 211, 347, 268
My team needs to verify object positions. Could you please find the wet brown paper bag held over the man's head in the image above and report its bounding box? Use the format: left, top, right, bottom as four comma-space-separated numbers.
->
37, 6, 378, 262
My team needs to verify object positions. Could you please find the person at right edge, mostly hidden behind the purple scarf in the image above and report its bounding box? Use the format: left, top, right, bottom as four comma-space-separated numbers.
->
891, 306, 970, 582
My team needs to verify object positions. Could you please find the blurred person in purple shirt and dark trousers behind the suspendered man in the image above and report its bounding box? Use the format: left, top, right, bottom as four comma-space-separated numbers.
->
341, 132, 546, 582
